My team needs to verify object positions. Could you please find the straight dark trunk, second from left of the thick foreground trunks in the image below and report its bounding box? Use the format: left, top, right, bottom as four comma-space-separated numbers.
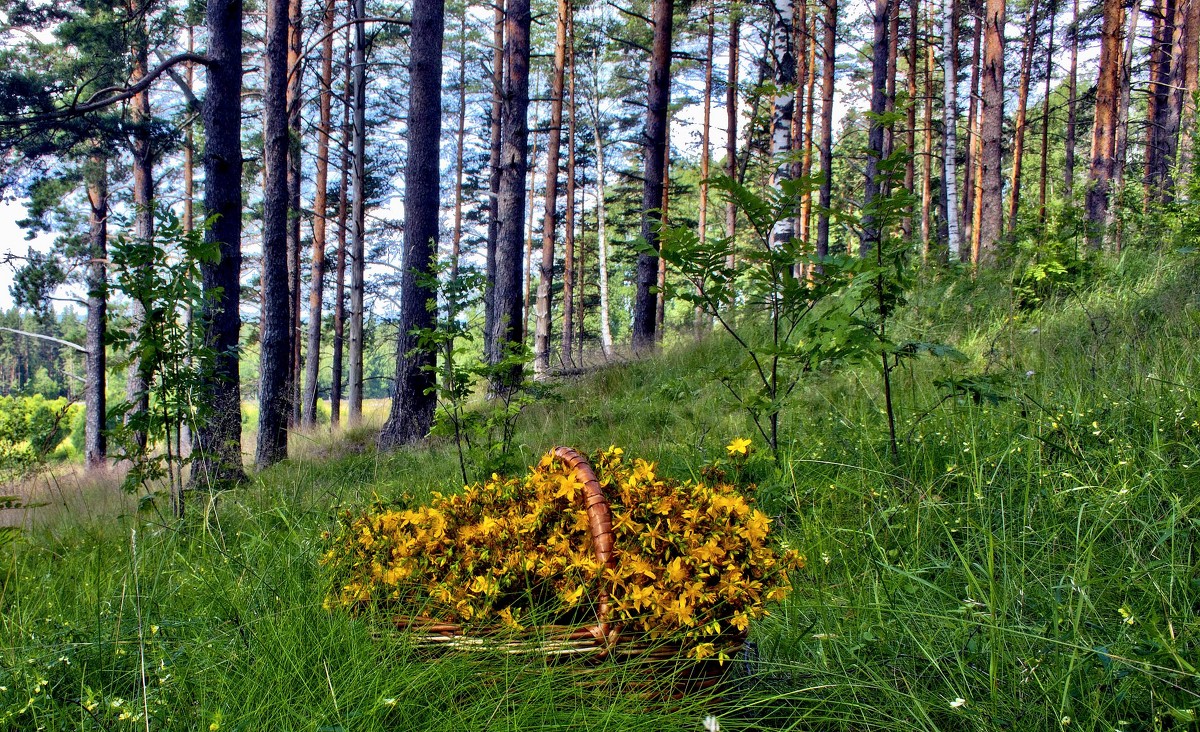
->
254, 0, 292, 468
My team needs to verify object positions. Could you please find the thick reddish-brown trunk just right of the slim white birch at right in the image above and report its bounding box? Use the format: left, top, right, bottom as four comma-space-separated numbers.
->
976, 0, 1004, 265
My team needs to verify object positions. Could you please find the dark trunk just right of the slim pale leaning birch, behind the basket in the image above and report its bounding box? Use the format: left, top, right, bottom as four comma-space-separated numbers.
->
632, 0, 674, 350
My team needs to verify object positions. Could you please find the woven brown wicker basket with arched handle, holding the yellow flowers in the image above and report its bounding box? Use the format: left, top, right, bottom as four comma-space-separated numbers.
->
391, 448, 745, 696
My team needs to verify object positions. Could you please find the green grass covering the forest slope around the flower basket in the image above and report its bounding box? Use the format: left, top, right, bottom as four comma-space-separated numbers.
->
0, 252, 1200, 730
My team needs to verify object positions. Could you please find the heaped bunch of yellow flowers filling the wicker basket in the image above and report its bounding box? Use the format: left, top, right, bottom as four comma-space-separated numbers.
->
323, 448, 804, 658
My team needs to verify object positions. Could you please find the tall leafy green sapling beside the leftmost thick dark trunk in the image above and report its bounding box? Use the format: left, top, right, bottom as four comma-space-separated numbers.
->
108, 209, 220, 516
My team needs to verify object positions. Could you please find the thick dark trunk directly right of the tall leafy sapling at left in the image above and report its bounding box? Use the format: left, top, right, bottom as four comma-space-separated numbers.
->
191, 0, 246, 488
